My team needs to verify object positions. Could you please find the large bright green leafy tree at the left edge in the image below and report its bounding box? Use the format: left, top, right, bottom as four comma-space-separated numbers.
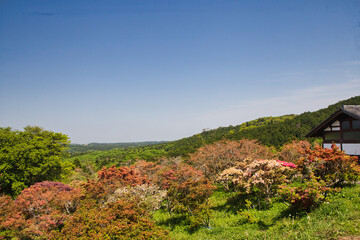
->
0, 126, 70, 196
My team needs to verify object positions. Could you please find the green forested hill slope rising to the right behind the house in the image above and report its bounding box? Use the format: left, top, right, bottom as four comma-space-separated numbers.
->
154, 96, 360, 156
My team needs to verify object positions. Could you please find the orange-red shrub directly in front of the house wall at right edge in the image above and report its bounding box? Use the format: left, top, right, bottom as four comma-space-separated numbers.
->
299, 144, 360, 186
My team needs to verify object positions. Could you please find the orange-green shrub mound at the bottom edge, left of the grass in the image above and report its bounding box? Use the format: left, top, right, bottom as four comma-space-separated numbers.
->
53, 198, 167, 239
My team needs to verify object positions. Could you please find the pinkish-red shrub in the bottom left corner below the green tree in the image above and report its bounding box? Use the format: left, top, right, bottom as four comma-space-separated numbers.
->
0, 181, 82, 239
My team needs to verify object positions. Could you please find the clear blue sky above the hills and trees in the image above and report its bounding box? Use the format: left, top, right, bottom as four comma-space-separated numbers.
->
0, 0, 360, 143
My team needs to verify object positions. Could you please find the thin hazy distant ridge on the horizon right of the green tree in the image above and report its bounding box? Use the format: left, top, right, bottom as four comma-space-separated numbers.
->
69, 141, 166, 154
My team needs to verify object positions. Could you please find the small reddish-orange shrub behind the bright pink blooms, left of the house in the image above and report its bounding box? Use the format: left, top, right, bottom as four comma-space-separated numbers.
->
279, 140, 311, 164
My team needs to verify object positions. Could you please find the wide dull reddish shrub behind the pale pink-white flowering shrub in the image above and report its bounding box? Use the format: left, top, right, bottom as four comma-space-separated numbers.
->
190, 139, 273, 181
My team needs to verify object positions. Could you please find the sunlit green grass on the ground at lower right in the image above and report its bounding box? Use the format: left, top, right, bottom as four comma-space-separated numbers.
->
154, 185, 360, 240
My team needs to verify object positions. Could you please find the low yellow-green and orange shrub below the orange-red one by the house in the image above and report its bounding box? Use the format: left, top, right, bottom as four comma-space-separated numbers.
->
278, 177, 340, 211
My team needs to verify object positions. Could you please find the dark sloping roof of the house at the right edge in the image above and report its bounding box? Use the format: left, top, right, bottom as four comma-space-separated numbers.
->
306, 105, 360, 137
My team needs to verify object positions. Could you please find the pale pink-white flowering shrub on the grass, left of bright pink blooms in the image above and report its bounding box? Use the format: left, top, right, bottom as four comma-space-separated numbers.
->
218, 159, 293, 200
